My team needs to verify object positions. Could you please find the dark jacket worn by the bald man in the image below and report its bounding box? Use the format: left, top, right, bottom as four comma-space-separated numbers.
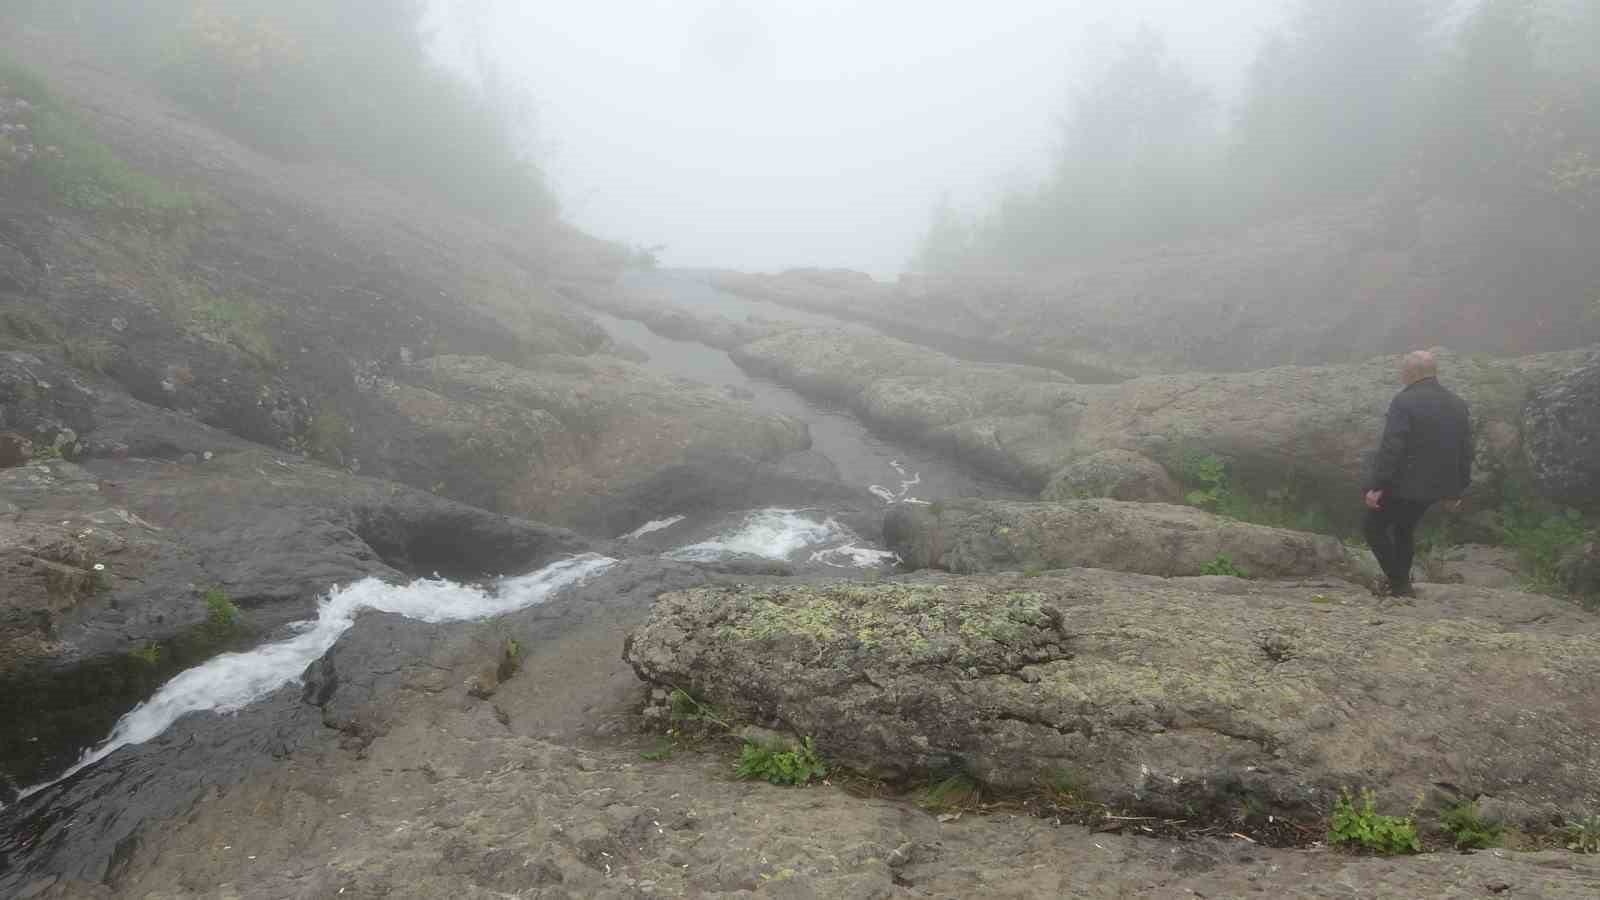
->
1366, 378, 1472, 500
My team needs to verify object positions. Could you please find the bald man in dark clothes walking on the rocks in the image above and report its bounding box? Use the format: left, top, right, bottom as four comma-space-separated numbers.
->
1366, 351, 1472, 597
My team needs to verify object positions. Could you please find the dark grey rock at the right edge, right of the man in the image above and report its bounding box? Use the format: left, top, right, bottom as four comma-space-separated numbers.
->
1523, 359, 1600, 508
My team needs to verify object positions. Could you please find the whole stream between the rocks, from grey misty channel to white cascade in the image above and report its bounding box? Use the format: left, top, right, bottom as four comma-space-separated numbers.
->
22, 272, 1018, 796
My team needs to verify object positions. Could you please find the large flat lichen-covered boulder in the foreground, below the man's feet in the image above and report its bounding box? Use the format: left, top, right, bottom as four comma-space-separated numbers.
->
624, 570, 1600, 831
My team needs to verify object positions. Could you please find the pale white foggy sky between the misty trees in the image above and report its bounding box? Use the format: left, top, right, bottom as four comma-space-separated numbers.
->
477, 0, 1288, 277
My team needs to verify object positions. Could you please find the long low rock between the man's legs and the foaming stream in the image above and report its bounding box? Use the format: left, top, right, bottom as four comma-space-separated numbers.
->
883, 500, 1355, 578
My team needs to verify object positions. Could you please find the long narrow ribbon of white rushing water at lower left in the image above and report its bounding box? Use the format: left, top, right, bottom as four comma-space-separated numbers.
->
22, 554, 616, 796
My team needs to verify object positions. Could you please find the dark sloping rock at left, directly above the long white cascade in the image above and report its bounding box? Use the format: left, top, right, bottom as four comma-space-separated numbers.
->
0, 450, 586, 783
